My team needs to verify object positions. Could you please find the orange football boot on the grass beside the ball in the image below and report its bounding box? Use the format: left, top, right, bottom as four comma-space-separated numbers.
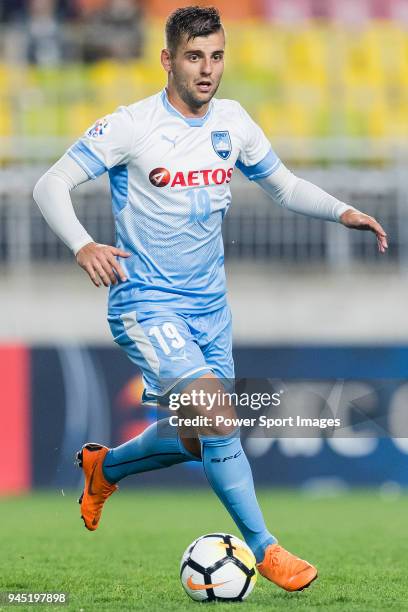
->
257, 544, 317, 591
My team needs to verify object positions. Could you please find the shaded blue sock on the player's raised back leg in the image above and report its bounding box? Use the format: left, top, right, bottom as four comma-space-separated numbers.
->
102, 418, 201, 483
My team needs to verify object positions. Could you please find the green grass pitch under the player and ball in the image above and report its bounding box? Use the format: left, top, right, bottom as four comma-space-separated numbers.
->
0, 489, 408, 612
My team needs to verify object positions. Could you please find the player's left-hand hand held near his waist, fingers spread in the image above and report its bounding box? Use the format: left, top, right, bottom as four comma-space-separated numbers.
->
76, 242, 130, 287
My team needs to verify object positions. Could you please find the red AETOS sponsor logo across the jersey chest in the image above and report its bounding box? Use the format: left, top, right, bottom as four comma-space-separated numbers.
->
149, 168, 234, 187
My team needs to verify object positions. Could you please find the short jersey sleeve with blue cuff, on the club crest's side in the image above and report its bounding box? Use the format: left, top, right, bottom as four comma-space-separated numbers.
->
235, 106, 281, 181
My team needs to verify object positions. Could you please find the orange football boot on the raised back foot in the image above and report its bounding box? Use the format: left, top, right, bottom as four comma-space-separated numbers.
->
76, 442, 119, 531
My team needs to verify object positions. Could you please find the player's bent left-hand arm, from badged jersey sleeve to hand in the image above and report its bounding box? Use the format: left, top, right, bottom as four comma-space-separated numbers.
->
33, 108, 133, 287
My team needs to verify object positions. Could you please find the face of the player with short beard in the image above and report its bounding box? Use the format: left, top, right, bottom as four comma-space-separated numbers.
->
165, 30, 225, 108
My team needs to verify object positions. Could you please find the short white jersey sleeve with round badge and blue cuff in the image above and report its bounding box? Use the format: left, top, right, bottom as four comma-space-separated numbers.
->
68, 106, 135, 179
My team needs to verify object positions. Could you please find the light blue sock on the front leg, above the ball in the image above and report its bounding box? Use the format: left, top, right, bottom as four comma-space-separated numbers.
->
200, 432, 277, 563
